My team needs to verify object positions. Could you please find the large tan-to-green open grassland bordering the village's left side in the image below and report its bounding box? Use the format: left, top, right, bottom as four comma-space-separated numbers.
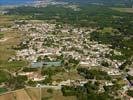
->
0, 32, 26, 70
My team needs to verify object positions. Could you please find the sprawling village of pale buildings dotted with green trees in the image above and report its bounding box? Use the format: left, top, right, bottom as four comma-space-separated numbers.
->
1, 21, 133, 99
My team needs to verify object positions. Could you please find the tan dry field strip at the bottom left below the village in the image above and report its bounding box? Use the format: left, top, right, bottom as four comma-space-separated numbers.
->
0, 88, 77, 100
